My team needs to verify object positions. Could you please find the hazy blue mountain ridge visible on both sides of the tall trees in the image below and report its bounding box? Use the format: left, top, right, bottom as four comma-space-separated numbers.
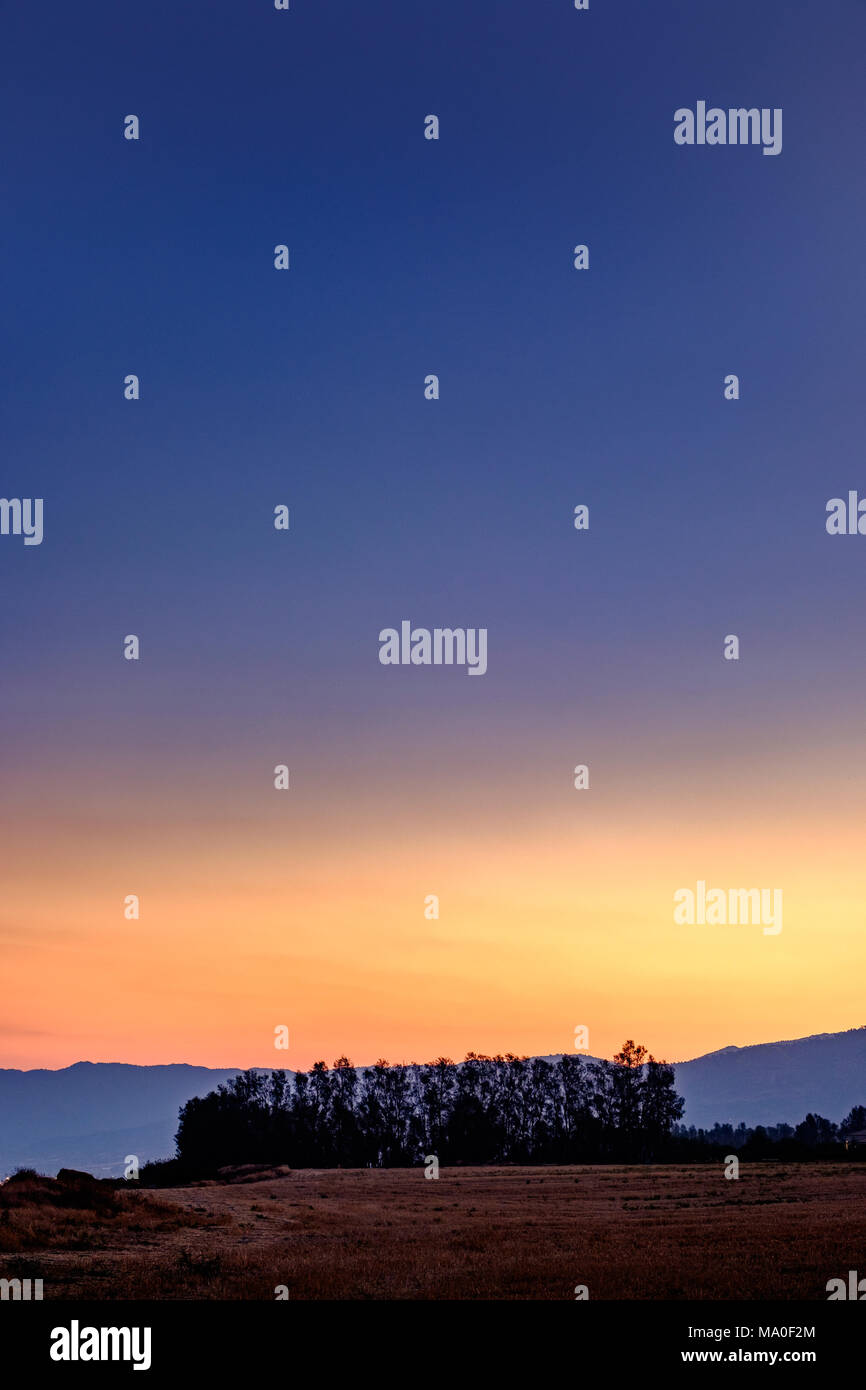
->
0, 1027, 866, 1177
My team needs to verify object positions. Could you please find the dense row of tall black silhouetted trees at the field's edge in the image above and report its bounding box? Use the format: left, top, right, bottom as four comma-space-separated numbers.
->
167, 1040, 684, 1176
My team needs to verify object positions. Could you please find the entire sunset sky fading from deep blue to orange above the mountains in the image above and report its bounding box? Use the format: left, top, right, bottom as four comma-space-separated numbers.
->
0, 0, 866, 1068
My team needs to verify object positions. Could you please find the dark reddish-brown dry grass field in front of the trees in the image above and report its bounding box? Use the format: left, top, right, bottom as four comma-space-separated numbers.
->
0, 1163, 866, 1300
